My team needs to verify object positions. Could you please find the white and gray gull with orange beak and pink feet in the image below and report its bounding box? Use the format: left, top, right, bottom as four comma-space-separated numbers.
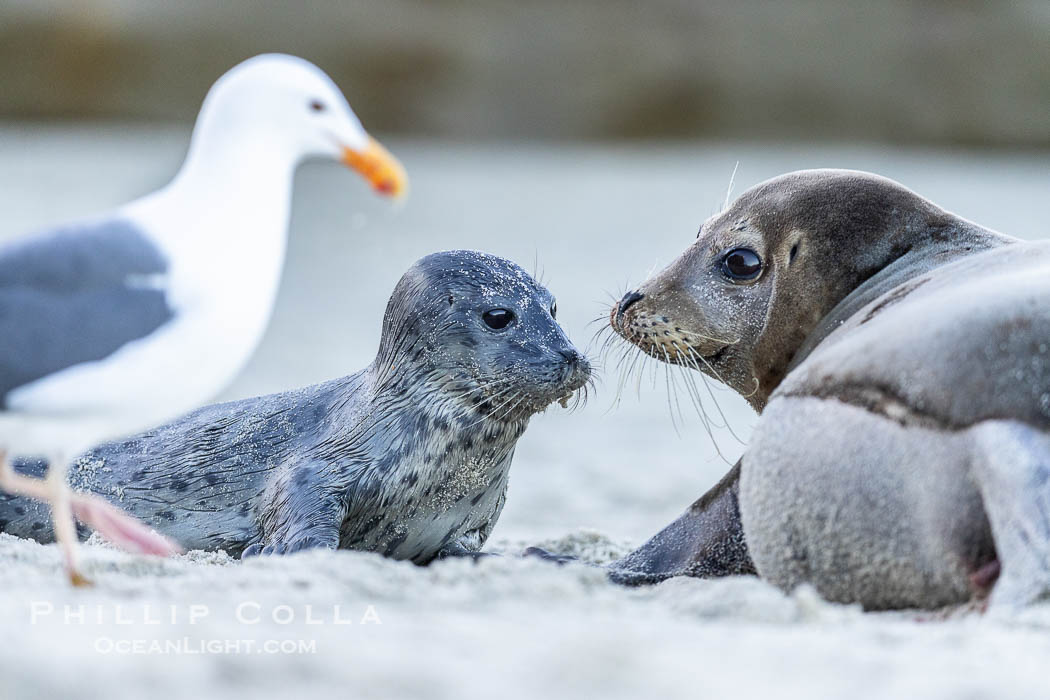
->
0, 54, 407, 585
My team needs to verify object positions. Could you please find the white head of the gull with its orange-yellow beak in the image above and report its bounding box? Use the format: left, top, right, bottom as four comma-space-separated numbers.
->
194, 54, 407, 196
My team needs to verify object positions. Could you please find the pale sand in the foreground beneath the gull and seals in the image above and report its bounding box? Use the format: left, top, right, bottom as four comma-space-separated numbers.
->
6, 534, 1050, 699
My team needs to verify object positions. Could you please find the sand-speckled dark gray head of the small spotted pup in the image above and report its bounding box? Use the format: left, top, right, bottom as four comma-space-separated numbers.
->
375, 251, 590, 422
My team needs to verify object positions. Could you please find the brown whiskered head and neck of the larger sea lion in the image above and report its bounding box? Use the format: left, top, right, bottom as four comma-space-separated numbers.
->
610, 170, 1003, 410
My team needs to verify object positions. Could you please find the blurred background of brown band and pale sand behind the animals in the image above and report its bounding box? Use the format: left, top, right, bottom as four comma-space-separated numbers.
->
0, 0, 1050, 543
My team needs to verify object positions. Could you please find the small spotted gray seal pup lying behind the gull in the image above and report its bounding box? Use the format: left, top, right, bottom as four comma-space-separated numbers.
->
0, 251, 590, 564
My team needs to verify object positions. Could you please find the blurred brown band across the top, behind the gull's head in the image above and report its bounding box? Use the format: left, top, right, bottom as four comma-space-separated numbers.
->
0, 0, 1050, 147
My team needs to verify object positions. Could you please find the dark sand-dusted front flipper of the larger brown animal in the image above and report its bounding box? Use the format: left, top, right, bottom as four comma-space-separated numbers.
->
609, 458, 756, 586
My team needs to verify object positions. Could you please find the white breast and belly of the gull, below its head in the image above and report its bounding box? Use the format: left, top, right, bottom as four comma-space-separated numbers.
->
8, 175, 291, 433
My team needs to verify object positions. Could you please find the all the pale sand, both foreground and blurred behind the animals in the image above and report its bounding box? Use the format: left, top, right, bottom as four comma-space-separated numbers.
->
0, 127, 1050, 699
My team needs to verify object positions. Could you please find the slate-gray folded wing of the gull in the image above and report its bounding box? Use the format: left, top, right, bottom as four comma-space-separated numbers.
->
0, 219, 173, 407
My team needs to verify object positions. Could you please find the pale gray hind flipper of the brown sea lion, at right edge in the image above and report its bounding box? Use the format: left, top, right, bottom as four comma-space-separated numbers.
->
973, 421, 1050, 607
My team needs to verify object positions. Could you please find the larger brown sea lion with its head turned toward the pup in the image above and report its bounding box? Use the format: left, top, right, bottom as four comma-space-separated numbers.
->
612, 170, 1050, 609
